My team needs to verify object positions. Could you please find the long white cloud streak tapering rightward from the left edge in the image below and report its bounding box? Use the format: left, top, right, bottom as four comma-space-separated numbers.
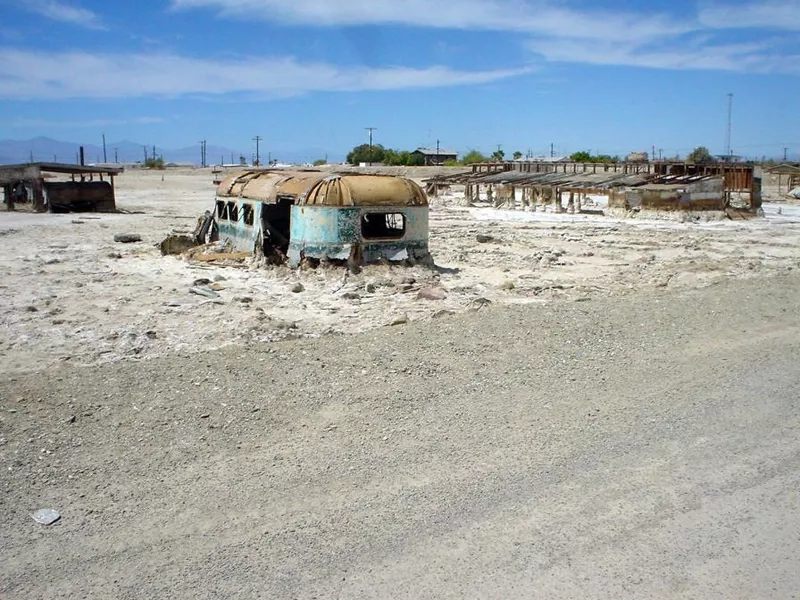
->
0, 49, 529, 99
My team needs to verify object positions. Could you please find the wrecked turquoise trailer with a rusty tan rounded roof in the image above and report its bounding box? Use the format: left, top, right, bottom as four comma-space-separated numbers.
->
214, 170, 430, 267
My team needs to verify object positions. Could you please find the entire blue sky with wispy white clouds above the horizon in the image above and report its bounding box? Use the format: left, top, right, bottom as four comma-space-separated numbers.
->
0, 0, 800, 161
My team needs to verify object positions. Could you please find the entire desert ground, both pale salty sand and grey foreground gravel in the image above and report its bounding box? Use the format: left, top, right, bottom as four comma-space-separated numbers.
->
0, 169, 800, 598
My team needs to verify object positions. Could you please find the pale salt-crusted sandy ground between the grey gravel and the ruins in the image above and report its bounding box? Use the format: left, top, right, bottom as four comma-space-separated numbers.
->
0, 170, 800, 373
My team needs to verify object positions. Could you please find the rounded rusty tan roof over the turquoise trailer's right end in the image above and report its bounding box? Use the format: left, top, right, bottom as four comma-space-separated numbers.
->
298, 174, 428, 206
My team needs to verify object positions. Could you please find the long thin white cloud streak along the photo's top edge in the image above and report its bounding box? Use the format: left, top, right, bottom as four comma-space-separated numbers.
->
172, 0, 693, 40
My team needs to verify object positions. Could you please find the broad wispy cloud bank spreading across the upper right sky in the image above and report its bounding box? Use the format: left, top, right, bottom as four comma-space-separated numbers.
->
172, 0, 800, 73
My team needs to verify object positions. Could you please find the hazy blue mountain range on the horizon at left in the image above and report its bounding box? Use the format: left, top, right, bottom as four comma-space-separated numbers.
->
0, 137, 334, 165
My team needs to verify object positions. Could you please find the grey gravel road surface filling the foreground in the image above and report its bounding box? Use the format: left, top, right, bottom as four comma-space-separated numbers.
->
0, 269, 800, 599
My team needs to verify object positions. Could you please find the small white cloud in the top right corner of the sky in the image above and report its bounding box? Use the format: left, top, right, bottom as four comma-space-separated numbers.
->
699, 0, 800, 31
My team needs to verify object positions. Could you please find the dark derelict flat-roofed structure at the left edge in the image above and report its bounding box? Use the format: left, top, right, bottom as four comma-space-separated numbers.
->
0, 163, 124, 213
